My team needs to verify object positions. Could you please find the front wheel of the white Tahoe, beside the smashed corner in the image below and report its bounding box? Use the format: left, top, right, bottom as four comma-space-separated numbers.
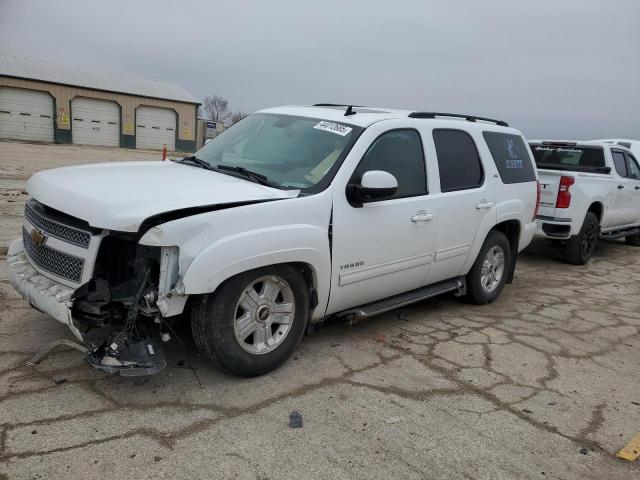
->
191, 265, 309, 377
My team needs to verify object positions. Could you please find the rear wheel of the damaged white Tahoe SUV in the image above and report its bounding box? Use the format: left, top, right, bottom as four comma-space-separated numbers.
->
467, 230, 511, 305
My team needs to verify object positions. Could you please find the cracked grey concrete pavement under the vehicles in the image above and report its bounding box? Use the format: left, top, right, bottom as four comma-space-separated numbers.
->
0, 142, 640, 480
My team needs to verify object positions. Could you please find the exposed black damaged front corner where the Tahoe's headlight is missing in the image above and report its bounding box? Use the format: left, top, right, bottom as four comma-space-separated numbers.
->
71, 232, 186, 376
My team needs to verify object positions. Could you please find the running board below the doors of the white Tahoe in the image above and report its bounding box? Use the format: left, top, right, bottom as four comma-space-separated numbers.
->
337, 277, 466, 319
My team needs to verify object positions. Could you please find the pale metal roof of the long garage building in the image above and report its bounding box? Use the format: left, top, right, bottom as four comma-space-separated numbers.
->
0, 53, 200, 104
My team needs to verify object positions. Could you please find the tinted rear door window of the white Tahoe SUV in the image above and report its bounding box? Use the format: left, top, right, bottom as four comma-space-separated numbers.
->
433, 129, 484, 192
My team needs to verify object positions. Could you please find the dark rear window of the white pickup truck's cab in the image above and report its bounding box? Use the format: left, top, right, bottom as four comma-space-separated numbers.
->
531, 144, 606, 173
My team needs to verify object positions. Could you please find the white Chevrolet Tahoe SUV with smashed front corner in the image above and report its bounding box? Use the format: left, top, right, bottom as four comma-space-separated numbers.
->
7, 104, 538, 376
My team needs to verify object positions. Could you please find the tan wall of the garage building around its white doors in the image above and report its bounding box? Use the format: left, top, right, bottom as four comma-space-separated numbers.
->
0, 76, 197, 152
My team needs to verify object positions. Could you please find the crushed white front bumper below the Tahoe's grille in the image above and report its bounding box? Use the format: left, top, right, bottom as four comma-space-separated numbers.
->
7, 239, 83, 341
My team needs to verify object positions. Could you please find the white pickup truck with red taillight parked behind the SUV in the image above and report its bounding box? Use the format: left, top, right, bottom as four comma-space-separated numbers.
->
530, 140, 640, 265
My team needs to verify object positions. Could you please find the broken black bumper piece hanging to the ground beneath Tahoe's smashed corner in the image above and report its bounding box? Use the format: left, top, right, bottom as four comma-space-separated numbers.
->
86, 332, 167, 377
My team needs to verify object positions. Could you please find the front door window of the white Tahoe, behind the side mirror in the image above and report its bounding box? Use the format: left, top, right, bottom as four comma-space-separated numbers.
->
353, 130, 427, 200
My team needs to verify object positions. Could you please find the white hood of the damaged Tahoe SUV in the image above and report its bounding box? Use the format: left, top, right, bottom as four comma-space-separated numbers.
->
27, 162, 299, 232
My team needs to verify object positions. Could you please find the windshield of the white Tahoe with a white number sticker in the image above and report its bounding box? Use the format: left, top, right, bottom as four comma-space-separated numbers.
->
195, 114, 361, 189
